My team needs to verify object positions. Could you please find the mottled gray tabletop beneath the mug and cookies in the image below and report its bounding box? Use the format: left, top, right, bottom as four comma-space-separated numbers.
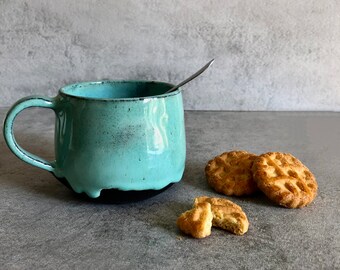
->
0, 108, 340, 269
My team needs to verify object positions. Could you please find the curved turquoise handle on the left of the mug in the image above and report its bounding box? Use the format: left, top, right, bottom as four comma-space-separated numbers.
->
3, 96, 56, 174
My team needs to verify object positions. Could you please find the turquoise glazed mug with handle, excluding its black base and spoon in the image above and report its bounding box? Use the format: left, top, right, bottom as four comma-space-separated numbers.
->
4, 81, 186, 198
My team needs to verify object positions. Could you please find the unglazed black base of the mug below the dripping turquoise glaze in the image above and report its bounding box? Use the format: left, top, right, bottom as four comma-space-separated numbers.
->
57, 178, 173, 204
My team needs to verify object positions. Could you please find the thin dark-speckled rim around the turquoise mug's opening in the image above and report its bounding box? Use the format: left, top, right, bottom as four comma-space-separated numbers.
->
59, 80, 182, 101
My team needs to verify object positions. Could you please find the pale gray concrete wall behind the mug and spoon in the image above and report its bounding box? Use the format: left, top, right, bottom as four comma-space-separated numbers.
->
0, 0, 340, 110
